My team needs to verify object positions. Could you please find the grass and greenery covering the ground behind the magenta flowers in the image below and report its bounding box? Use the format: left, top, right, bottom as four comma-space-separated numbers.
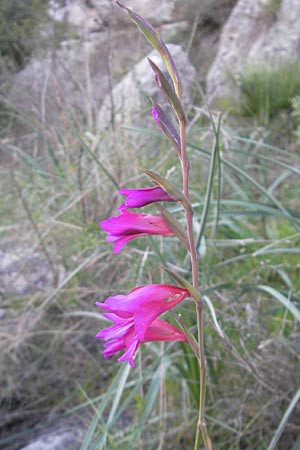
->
0, 3, 300, 450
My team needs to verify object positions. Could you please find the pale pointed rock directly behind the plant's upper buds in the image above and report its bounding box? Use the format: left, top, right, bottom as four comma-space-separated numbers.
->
97, 44, 196, 130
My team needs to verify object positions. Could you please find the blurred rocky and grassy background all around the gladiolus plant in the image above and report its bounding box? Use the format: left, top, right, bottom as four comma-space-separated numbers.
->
0, 0, 300, 450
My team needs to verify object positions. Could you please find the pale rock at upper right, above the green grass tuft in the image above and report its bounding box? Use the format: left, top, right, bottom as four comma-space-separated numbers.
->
206, 0, 300, 102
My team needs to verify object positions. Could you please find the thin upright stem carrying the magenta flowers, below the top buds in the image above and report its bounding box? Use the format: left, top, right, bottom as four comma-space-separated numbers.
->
180, 115, 212, 450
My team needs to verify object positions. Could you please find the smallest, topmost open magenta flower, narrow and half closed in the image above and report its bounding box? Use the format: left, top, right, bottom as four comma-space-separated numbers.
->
118, 186, 176, 211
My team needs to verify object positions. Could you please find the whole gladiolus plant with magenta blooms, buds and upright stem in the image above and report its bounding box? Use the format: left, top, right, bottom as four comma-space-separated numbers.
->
97, 1, 212, 450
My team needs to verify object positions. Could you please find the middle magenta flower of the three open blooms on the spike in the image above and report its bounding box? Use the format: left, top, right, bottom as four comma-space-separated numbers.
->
100, 210, 174, 253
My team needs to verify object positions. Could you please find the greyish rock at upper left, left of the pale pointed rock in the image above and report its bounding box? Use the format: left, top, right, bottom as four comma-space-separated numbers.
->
9, 33, 113, 127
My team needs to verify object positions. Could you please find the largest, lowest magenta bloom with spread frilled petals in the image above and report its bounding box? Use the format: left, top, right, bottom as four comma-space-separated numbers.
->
96, 284, 189, 367
